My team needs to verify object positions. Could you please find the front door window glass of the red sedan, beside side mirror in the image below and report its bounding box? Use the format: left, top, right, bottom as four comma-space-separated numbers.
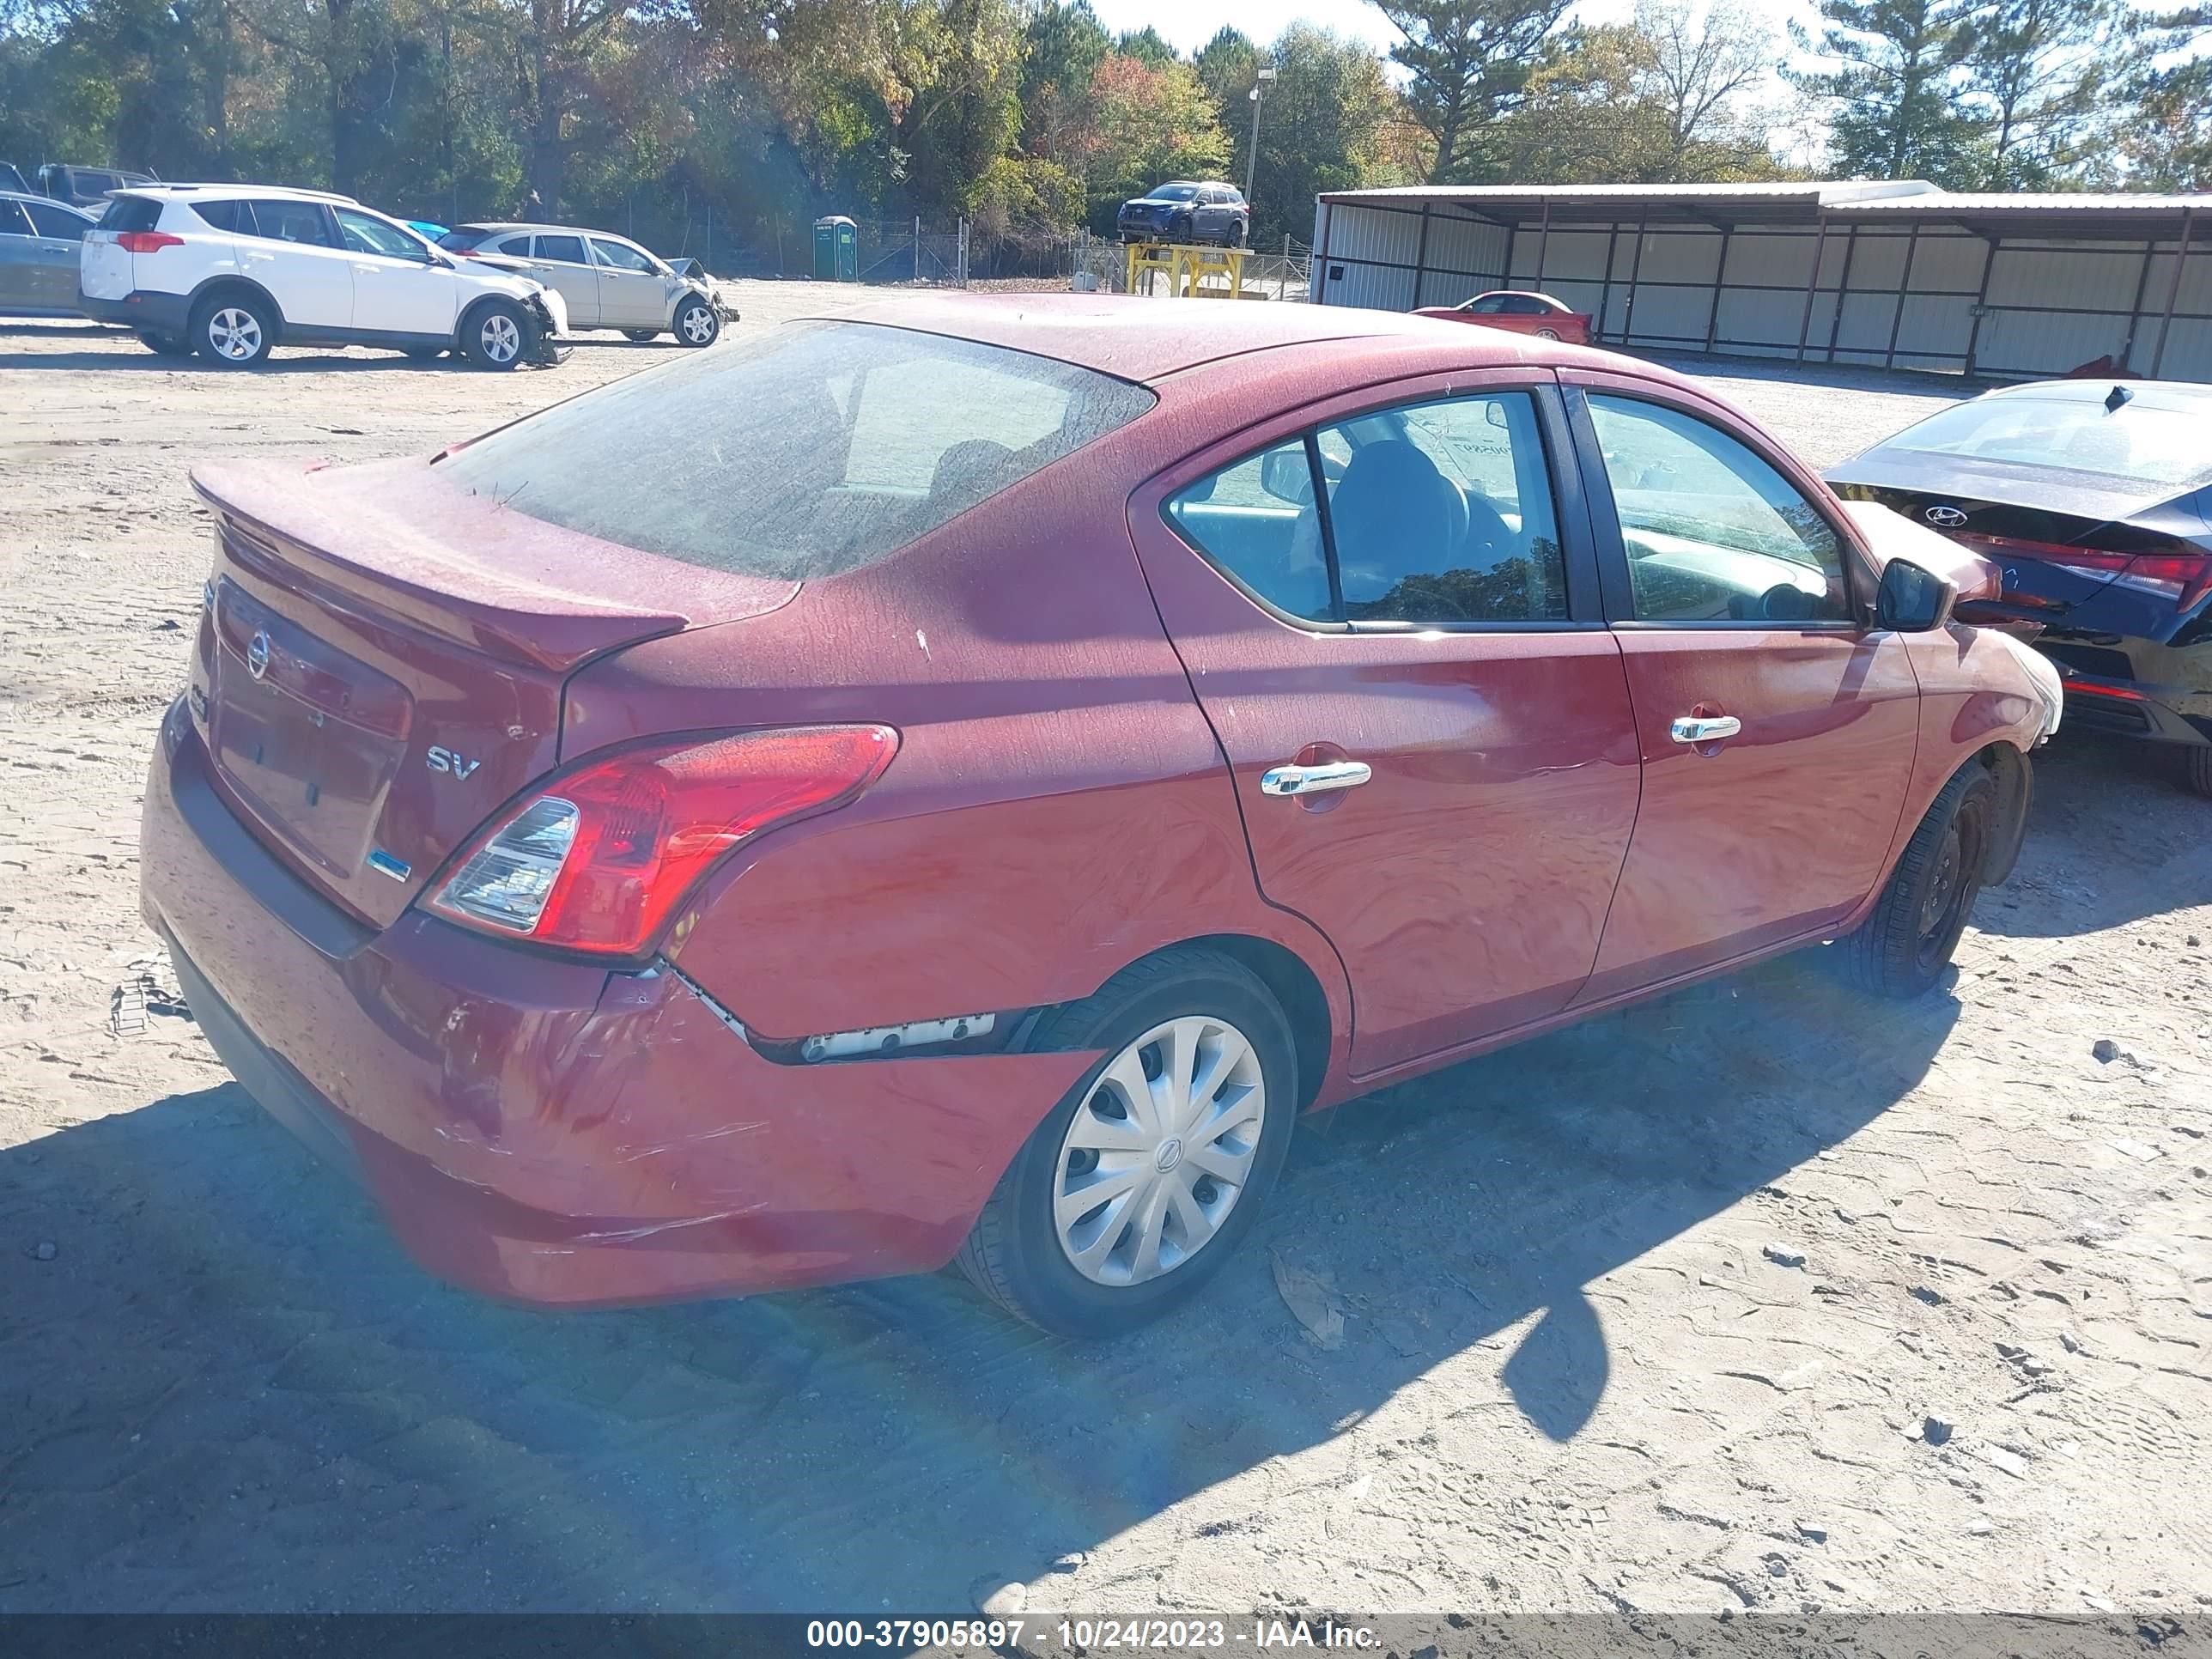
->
1590, 394, 1851, 622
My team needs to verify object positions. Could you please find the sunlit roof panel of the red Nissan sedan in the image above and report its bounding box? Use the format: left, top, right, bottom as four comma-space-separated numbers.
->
807, 292, 1672, 398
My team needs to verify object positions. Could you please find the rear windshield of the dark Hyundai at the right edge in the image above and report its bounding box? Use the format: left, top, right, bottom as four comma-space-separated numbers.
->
1882, 396, 2212, 484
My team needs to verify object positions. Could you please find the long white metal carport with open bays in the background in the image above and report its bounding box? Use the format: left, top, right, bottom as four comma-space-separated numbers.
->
1312, 179, 2212, 380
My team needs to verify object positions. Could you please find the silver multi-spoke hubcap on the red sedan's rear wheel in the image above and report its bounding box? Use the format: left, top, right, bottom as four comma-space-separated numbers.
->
1053, 1015, 1267, 1287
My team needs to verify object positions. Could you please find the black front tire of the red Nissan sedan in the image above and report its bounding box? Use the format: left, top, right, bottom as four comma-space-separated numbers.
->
1836, 763, 1997, 998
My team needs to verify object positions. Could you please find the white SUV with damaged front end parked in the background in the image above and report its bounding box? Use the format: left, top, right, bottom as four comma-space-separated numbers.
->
77, 184, 568, 369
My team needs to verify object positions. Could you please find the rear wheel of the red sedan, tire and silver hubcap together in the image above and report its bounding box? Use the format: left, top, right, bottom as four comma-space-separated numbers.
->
960, 947, 1298, 1336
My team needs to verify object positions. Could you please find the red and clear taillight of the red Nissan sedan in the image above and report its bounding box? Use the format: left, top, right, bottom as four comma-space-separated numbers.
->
429, 726, 898, 956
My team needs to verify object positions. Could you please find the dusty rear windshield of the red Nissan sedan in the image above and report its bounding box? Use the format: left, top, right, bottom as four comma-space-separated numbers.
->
438, 323, 1152, 581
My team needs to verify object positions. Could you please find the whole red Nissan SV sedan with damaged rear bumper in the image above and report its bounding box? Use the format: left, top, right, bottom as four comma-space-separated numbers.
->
143, 296, 2059, 1334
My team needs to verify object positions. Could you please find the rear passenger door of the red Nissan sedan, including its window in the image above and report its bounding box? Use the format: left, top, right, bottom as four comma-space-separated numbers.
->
1130, 369, 1637, 1078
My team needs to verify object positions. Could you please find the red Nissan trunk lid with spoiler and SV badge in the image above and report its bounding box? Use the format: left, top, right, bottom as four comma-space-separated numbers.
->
192, 460, 796, 927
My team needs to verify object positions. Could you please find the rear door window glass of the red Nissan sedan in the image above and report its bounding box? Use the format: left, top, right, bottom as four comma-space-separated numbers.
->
1168, 392, 1566, 626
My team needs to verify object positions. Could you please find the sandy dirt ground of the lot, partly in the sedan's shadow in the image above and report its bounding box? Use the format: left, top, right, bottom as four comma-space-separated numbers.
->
0, 283, 2212, 1614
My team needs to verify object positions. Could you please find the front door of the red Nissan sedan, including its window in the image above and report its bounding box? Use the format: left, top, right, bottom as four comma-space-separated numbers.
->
1568, 376, 1920, 1002
